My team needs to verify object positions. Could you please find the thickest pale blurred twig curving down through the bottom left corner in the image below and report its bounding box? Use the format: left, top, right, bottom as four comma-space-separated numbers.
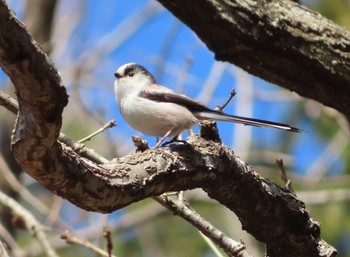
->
0, 191, 58, 257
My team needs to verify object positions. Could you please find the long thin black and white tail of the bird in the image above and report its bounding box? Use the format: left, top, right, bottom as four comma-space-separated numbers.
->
195, 111, 303, 132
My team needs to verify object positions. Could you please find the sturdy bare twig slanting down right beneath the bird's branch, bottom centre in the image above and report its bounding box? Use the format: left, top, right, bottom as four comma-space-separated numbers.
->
153, 195, 251, 257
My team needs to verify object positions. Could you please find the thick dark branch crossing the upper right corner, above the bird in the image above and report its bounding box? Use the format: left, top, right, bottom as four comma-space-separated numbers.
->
158, 0, 350, 120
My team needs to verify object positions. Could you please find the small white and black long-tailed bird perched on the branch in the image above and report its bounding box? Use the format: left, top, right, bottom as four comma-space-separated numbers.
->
114, 62, 302, 148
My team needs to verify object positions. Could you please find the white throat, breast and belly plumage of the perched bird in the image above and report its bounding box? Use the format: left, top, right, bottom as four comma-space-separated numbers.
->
114, 70, 197, 137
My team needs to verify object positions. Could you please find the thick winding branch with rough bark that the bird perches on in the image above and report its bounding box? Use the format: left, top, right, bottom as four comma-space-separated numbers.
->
0, 0, 336, 257
